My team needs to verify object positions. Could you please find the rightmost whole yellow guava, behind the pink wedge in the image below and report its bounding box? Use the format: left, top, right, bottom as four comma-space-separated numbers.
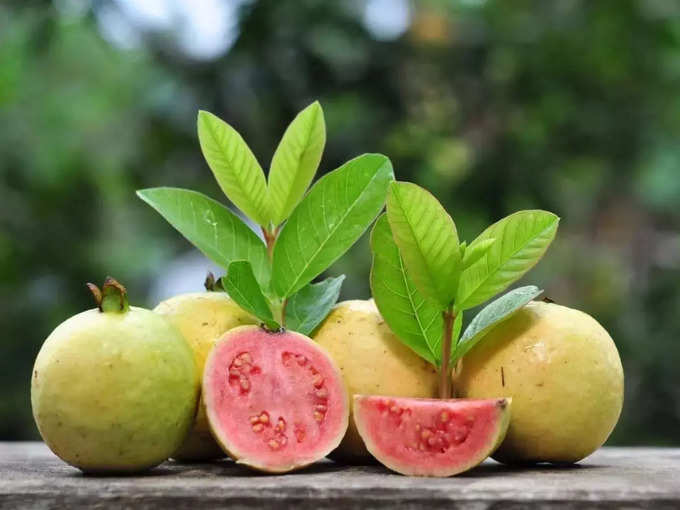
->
453, 302, 623, 463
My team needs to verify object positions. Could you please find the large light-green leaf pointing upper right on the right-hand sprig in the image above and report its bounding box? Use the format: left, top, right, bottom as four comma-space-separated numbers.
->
456, 210, 560, 310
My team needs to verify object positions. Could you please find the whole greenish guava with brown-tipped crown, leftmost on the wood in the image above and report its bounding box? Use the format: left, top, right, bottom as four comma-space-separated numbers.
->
31, 278, 200, 473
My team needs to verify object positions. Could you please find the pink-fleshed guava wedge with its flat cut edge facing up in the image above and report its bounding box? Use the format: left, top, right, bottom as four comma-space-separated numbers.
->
354, 395, 510, 477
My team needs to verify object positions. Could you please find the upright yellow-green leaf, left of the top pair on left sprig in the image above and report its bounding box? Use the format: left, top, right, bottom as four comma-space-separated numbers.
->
198, 111, 270, 226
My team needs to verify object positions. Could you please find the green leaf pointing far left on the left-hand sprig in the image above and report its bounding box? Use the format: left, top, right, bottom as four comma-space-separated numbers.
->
137, 188, 271, 287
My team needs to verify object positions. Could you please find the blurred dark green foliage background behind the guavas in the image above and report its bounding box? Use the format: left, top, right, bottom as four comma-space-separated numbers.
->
0, 0, 680, 445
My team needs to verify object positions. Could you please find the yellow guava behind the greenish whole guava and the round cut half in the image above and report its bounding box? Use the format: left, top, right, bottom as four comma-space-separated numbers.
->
154, 292, 257, 462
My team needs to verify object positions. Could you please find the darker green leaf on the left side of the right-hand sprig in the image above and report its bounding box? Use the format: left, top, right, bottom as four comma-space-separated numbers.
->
371, 214, 444, 365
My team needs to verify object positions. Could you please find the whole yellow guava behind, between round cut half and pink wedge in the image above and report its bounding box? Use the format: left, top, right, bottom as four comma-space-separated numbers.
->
313, 299, 437, 463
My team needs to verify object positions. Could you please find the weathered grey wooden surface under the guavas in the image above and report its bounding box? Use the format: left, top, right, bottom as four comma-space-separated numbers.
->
0, 443, 680, 510
